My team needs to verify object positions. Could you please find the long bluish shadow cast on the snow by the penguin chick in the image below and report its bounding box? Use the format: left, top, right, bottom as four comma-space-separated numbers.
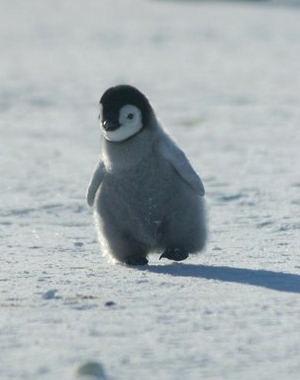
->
144, 263, 300, 293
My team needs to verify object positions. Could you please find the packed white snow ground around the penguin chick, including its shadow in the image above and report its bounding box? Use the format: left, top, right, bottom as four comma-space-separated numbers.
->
0, 0, 300, 380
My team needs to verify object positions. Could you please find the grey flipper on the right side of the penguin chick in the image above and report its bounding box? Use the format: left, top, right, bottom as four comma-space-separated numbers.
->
158, 134, 205, 196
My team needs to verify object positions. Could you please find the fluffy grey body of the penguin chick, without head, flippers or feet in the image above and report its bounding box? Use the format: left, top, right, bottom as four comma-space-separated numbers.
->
95, 120, 206, 261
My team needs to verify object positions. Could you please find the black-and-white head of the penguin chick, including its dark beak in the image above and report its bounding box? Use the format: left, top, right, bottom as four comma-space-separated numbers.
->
100, 85, 153, 142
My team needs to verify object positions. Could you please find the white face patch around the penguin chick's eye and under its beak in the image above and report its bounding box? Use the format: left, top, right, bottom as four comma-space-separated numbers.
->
101, 104, 143, 142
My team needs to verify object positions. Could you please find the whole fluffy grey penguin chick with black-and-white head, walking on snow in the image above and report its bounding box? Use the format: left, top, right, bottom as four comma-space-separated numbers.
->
87, 85, 207, 265
